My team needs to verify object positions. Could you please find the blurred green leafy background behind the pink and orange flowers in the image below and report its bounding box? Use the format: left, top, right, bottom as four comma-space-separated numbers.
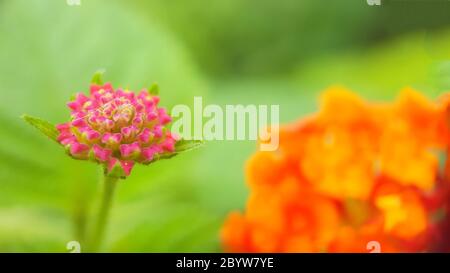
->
0, 0, 450, 252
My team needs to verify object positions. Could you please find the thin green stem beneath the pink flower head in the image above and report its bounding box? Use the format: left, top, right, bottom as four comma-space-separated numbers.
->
92, 172, 119, 252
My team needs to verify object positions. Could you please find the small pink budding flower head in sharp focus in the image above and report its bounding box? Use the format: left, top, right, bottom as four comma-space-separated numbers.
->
56, 83, 176, 177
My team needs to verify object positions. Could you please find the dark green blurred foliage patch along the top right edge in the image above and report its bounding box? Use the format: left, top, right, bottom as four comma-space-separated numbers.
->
130, 0, 450, 78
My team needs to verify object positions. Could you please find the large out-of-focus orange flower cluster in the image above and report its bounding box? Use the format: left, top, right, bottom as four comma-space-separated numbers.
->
221, 87, 450, 252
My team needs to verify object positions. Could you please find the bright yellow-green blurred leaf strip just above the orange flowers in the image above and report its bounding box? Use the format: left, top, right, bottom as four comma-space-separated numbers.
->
296, 30, 450, 100
